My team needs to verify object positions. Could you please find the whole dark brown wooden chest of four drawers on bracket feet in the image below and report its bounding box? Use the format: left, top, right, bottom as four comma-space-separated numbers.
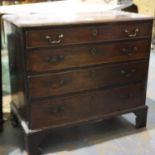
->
4, 11, 152, 155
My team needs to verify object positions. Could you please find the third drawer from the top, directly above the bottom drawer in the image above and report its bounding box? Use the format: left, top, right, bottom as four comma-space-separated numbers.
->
28, 61, 147, 98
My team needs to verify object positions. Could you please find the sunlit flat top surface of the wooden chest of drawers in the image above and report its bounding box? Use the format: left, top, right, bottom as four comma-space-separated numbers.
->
3, 10, 153, 28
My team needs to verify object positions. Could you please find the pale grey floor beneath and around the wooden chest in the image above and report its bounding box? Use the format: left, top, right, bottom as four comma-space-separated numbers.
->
0, 51, 155, 155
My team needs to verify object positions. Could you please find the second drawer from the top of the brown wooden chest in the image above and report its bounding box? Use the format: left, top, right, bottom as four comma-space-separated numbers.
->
26, 39, 150, 73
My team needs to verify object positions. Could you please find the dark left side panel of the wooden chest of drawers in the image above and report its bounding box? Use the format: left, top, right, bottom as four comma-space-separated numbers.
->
7, 28, 28, 121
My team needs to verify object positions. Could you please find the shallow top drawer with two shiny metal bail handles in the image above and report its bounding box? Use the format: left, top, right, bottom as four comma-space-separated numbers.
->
25, 22, 151, 48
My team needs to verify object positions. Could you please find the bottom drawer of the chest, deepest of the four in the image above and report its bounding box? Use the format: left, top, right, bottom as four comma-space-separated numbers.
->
30, 84, 145, 129
